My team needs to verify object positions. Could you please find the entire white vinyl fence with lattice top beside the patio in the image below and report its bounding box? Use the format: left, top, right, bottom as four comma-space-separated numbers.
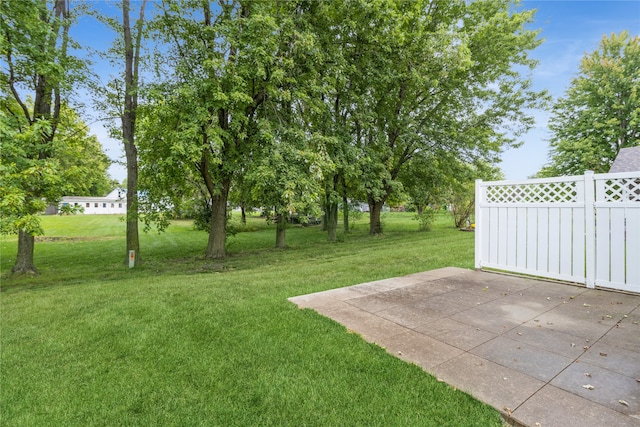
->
475, 172, 640, 292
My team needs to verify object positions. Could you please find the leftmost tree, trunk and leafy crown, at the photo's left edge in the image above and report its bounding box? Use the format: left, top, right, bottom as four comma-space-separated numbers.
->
0, 0, 84, 273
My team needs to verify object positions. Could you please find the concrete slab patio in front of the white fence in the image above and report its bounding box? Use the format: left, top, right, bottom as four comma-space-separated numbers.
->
290, 268, 640, 427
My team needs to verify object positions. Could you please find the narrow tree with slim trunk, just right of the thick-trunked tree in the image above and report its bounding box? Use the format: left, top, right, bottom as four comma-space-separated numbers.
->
246, 2, 333, 248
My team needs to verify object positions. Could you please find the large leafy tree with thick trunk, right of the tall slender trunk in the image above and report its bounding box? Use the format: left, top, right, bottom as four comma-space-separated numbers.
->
139, 2, 338, 254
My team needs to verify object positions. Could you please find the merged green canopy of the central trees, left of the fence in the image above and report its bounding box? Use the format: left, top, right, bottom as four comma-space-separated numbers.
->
138, 0, 543, 244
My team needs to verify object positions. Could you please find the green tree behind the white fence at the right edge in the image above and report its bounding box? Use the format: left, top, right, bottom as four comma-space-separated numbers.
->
538, 31, 640, 177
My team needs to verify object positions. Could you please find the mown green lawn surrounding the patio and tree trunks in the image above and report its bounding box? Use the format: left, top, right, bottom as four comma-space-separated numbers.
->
0, 213, 501, 426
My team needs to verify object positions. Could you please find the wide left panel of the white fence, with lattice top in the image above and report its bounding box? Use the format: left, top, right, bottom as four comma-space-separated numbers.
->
476, 177, 584, 286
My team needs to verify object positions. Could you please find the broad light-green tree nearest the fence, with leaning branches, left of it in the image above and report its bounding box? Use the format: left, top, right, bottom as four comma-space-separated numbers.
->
358, 0, 542, 234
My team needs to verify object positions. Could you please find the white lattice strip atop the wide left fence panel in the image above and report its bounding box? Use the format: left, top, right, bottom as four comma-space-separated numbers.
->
485, 181, 579, 203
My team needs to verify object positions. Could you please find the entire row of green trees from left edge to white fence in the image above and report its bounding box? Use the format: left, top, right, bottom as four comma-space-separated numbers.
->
0, 0, 636, 272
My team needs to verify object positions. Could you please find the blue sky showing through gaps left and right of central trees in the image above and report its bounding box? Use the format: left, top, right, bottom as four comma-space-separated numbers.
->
72, 0, 640, 181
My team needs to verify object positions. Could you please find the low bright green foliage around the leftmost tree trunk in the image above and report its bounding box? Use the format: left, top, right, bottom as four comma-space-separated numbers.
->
0, 98, 110, 235
